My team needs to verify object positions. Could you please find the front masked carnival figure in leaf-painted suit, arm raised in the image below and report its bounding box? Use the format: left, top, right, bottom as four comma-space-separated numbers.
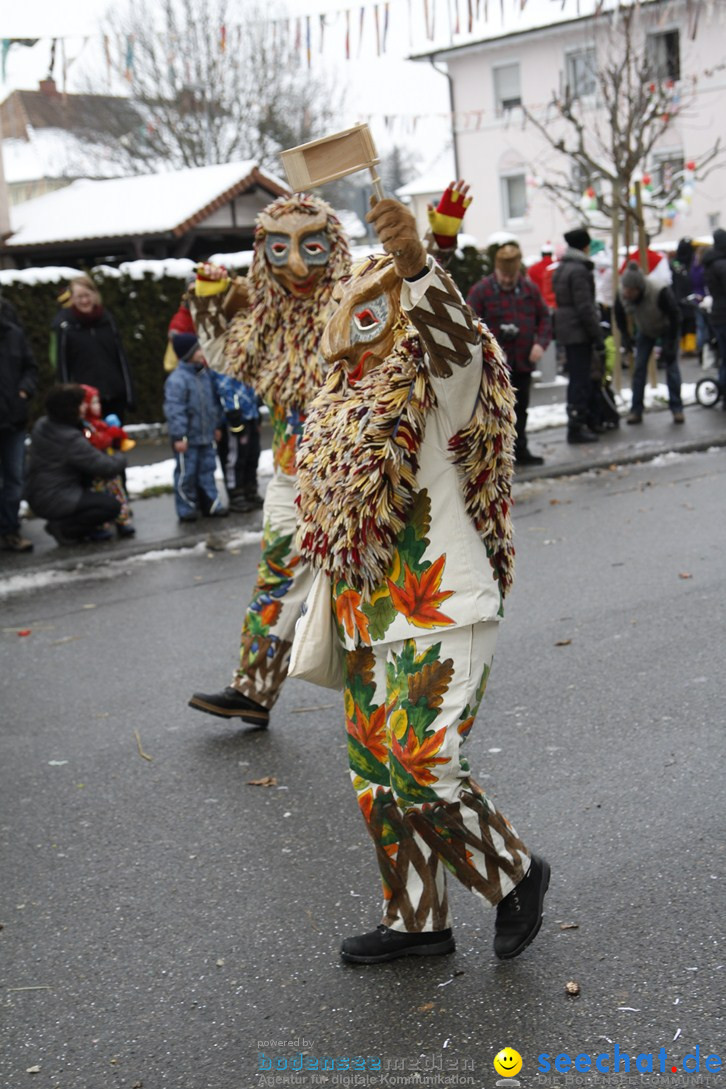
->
297, 200, 550, 963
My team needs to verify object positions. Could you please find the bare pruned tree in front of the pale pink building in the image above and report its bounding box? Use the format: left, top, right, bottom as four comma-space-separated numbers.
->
522, 3, 723, 237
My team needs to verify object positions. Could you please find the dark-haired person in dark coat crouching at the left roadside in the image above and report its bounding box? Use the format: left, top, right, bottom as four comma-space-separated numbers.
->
26, 386, 126, 545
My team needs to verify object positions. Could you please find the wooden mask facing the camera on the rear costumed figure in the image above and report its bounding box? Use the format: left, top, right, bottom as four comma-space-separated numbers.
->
259, 204, 331, 298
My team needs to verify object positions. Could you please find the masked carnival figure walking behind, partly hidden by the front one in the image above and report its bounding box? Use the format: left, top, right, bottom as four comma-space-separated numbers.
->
189, 194, 349, 727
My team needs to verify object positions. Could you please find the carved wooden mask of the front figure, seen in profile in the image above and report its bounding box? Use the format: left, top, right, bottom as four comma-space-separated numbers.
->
320, 258, 405, 383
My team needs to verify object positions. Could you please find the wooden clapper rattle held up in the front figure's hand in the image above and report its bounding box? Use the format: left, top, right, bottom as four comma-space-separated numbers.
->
280, 125, 383, 200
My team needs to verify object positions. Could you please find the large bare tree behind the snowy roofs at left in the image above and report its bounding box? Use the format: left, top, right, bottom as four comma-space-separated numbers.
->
88, 0, 342, 172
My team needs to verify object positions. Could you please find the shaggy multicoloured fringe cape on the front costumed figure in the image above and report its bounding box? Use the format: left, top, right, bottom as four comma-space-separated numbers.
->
298, 333, 514, 599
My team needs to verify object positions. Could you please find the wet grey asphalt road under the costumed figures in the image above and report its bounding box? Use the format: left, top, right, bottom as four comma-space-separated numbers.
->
0, 450, 726, 1089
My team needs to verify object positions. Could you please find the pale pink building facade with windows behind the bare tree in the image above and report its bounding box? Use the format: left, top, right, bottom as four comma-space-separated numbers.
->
413, 0, 726, 254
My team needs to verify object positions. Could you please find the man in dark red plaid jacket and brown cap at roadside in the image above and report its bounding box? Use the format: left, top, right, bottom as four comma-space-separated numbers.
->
467, 242, 552, 465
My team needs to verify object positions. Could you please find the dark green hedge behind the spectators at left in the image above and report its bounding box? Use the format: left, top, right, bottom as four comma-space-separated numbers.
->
2, 269, 192, 424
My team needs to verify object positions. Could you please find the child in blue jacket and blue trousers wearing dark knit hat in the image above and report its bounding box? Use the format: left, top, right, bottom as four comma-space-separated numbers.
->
164, 333, 227, 522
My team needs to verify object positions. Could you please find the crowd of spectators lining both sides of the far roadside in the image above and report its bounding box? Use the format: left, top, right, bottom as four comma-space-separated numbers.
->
0, 202, 726, 553
